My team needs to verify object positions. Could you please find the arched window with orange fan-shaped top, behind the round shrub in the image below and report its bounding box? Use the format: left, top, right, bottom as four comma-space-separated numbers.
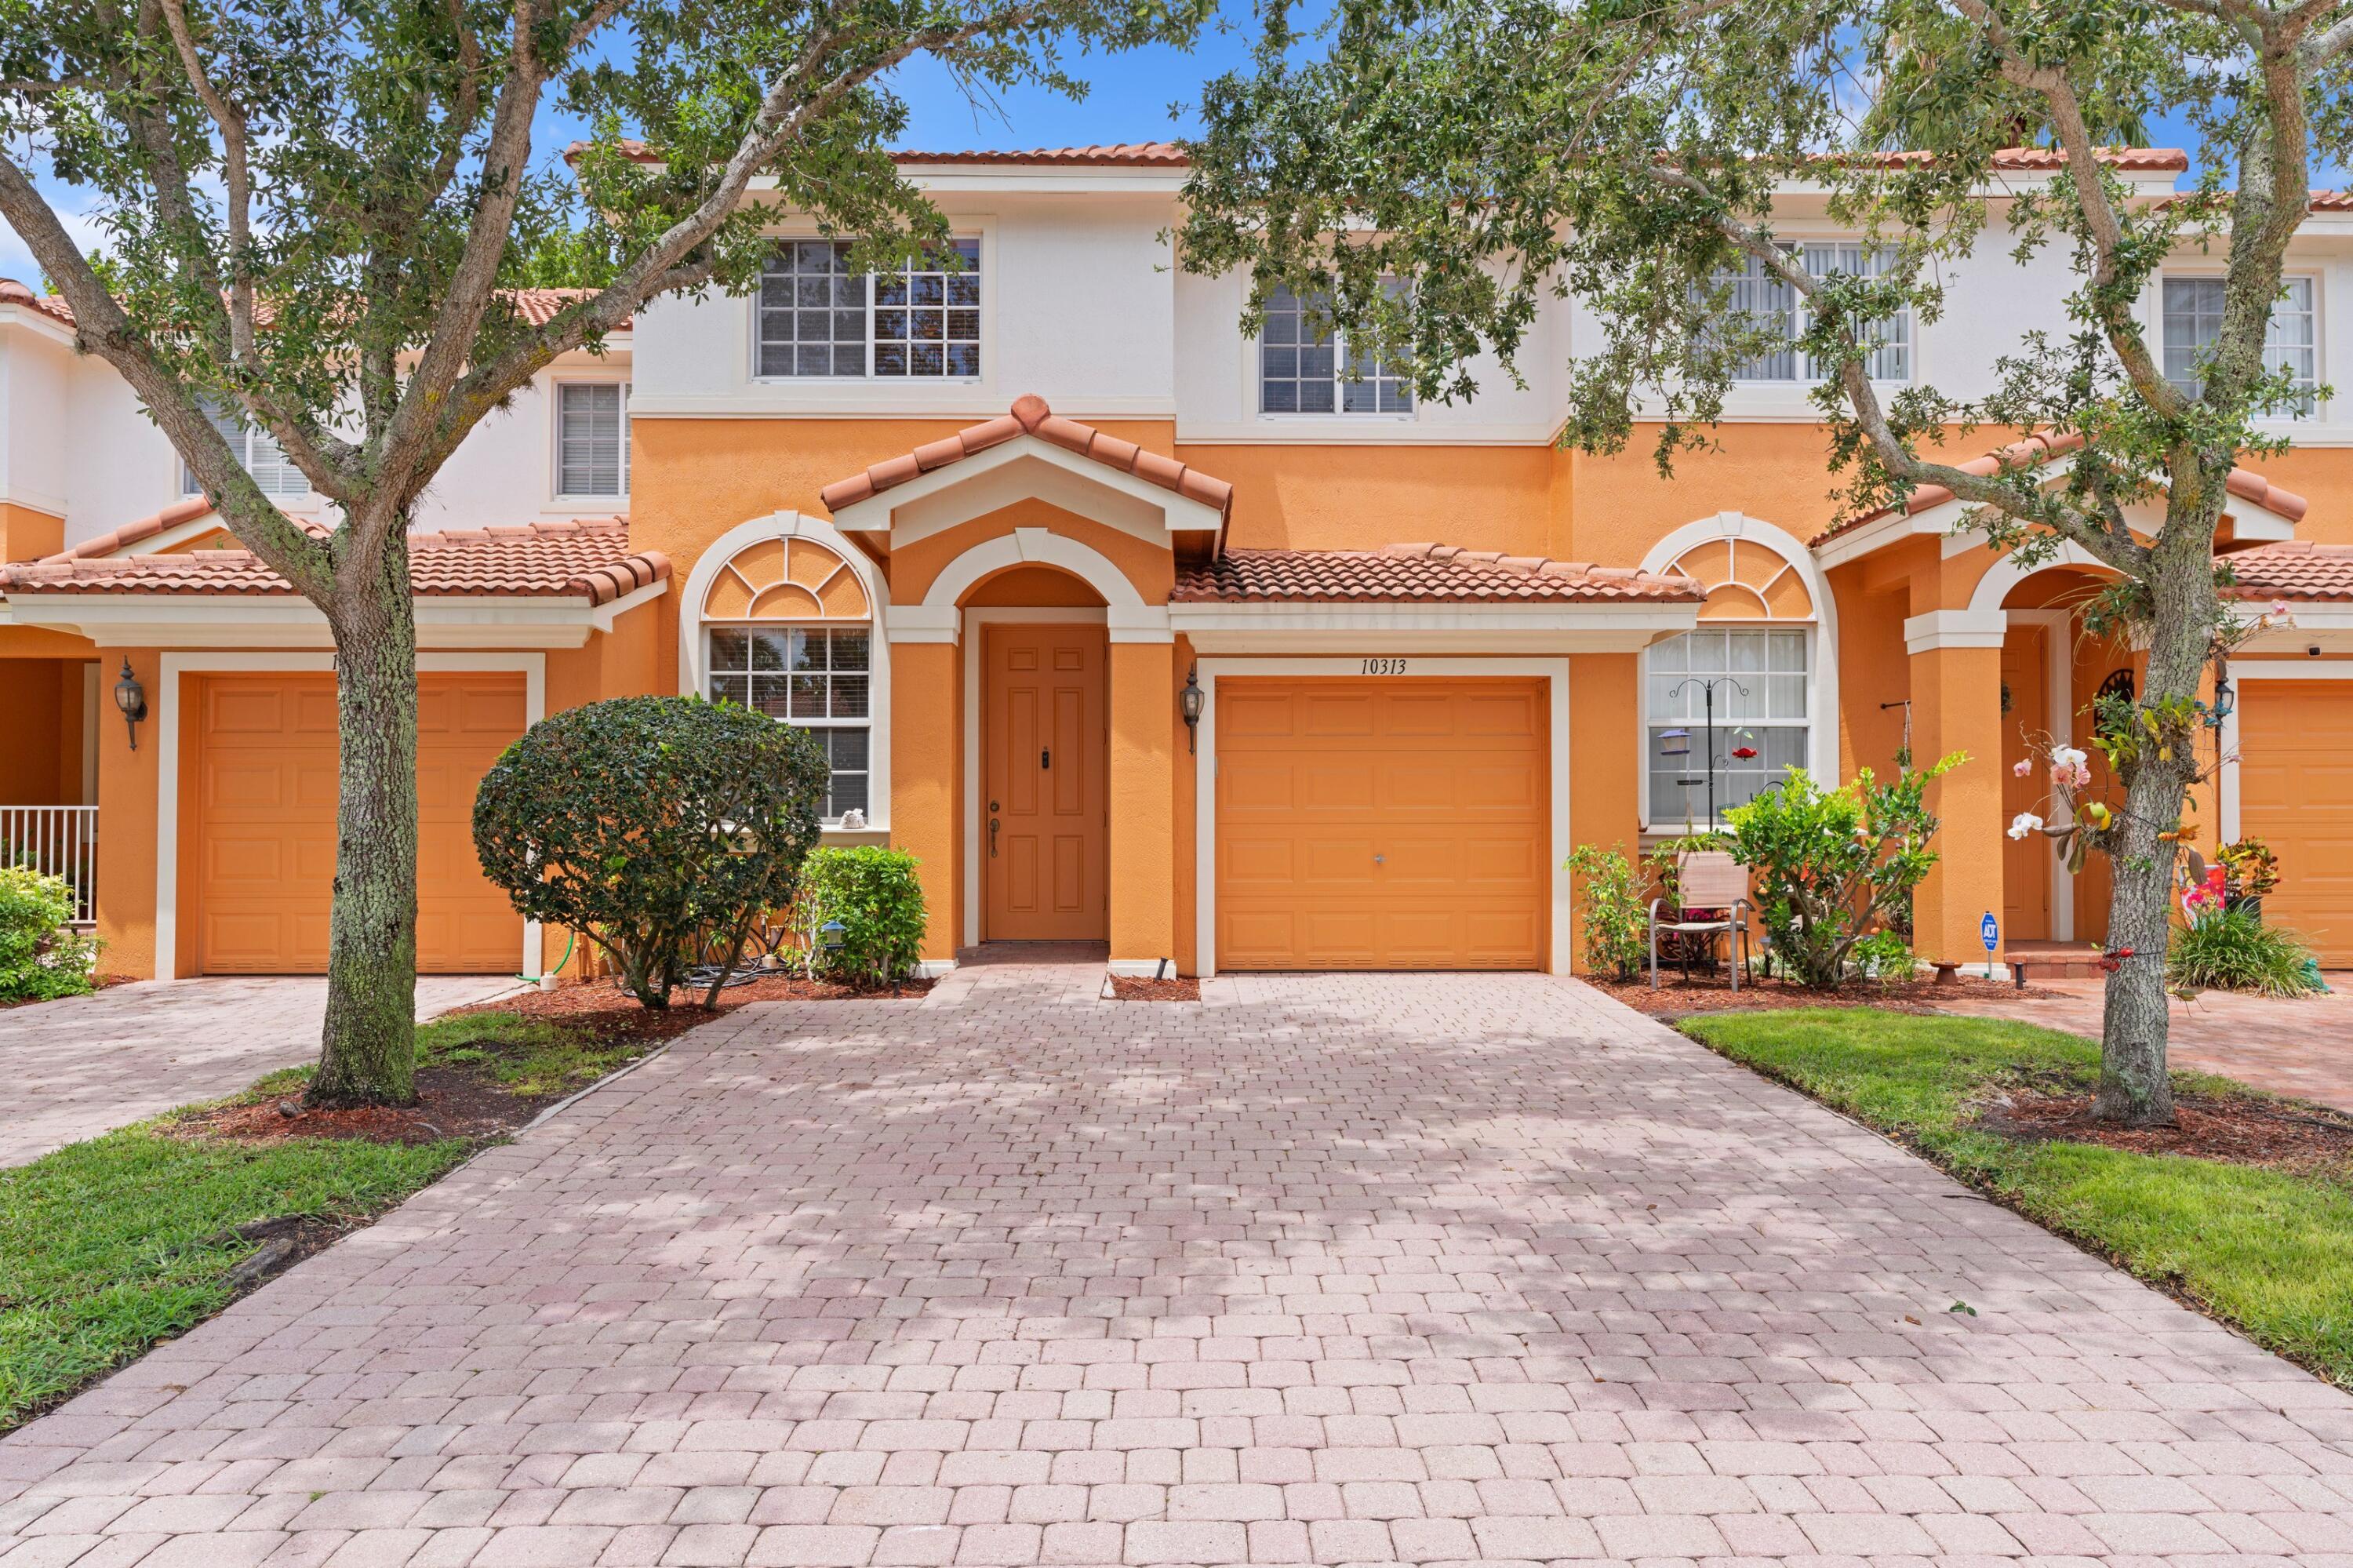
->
701, 539, 873, 822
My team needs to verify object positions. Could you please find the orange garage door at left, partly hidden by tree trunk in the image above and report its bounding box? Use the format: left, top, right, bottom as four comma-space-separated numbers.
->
188, 675, 522, 975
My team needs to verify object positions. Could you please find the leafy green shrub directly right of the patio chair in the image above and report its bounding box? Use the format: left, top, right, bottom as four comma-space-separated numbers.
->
1725, 751, 1967, 989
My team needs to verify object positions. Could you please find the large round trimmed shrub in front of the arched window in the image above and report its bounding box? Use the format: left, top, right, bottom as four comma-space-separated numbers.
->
473, 697, 828, 1008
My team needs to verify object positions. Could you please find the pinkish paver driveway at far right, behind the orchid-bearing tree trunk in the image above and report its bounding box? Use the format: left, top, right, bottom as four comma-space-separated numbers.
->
1948, 970, 2353, 1111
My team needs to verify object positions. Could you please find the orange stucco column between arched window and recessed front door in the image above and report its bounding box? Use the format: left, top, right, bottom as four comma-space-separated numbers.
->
889, 640, 965, 961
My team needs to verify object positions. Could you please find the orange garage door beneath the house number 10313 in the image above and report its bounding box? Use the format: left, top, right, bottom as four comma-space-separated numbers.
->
1217, 675, 1551, 970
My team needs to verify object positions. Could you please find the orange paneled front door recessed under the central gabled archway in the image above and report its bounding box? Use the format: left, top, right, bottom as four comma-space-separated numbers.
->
981, 626, 1111, 942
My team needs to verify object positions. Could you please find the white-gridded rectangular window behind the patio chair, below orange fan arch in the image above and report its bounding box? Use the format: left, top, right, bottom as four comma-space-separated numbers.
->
1642, 626, 1812, 831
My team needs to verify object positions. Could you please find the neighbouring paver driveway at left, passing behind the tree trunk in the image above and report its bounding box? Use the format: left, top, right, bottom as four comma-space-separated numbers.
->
0, 975, 515, 1166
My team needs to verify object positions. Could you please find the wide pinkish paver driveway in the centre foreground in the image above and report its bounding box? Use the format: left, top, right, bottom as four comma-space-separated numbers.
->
0, 970, 2353, 1568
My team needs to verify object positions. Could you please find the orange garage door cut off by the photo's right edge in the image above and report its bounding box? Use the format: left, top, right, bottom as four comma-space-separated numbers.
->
2238, 682, 2353, 968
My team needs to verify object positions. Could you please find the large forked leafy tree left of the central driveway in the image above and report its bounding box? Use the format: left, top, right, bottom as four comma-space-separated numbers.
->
0, 0, 1209, 1104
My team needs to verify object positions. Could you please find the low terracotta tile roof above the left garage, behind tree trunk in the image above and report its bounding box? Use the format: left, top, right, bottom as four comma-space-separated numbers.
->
0, 518, 671, 605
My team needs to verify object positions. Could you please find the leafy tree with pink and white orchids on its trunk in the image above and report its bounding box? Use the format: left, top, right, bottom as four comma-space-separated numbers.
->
1179, 0, 2353, 1123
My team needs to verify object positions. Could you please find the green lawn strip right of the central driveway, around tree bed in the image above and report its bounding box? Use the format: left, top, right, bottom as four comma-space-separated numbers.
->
1680, 1008, 2353, 1389
